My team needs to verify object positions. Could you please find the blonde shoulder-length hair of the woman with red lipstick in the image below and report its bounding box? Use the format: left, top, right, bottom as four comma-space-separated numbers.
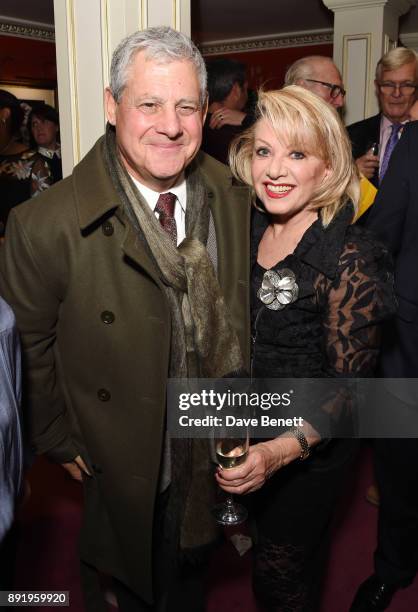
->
229, 85, 360, 227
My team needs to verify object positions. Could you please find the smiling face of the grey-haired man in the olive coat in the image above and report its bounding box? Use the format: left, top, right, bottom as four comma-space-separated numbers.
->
106, 51, 206, 192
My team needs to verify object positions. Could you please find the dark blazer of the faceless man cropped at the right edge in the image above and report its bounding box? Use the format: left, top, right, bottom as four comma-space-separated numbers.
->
366, 121, 418, 378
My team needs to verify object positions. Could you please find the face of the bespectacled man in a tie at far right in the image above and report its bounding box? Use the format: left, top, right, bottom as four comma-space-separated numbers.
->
375, 62, 416, 123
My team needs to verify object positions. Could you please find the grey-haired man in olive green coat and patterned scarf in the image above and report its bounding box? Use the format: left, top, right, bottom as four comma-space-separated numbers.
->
0, 28, 250, 611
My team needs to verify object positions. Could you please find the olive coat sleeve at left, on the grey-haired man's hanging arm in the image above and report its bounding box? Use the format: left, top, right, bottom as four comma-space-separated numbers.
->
0, 211, 79, 462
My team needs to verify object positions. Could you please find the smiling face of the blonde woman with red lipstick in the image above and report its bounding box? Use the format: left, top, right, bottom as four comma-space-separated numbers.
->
251, 119, 329, 218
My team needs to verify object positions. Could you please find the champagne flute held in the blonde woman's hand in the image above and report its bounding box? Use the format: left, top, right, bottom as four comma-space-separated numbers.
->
212, 427, 249, 525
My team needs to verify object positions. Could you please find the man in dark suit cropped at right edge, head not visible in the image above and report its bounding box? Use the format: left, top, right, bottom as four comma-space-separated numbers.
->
351, 121, 418, 612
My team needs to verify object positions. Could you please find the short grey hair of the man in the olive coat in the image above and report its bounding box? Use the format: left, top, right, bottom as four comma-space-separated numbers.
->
109, 26, 207, 105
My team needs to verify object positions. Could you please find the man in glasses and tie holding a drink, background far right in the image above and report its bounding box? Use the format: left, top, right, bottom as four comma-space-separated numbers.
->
347, 47, 418, 187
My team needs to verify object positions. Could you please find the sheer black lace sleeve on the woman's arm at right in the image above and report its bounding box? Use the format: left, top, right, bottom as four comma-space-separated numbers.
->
305, 232, 396, 439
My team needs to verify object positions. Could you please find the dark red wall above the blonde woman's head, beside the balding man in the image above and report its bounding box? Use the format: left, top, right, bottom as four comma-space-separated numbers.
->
203, 44, 332, 89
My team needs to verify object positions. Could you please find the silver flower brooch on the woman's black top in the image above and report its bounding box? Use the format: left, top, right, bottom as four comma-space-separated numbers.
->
257, 268, 299, 310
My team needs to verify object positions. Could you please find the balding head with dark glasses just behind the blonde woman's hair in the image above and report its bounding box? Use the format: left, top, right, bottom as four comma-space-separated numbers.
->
285, 55, 345, 108
